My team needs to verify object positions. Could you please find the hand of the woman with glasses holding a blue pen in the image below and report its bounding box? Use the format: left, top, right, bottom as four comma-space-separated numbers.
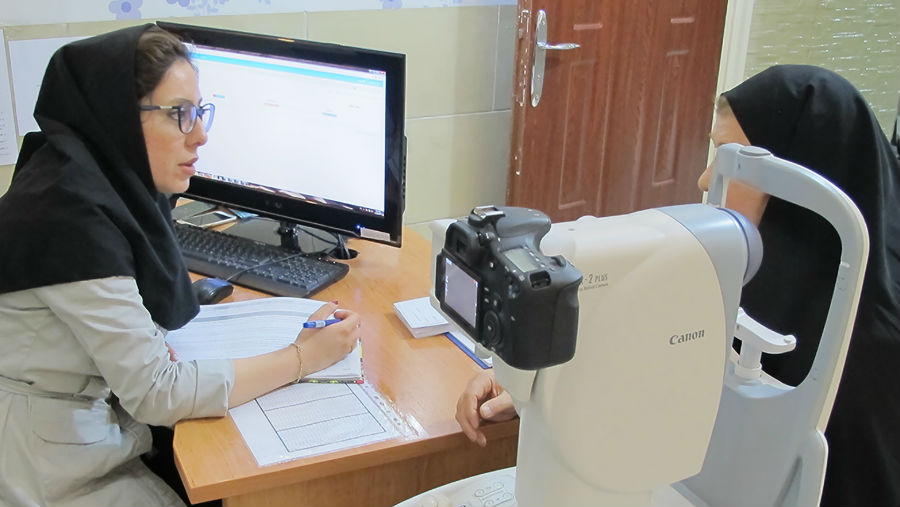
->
297, 303, 360, 377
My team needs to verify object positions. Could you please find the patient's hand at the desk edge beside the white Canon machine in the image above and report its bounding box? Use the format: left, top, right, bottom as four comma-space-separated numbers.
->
456, 373, 516, 447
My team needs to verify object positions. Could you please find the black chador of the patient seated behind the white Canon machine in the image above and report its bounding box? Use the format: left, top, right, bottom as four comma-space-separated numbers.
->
725, 65, 900, 506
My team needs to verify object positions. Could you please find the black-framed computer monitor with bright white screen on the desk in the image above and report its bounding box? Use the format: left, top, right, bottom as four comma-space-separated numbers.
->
159, 22, 406, 246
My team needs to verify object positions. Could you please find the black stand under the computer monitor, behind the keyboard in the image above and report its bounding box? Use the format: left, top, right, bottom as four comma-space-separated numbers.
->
225, 217, 356, 259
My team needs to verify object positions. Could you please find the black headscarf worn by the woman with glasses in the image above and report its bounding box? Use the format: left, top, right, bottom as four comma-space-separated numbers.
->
0, 25, 198, 329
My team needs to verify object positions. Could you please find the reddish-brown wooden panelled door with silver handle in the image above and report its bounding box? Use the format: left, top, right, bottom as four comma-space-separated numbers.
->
507, 0, 726, 221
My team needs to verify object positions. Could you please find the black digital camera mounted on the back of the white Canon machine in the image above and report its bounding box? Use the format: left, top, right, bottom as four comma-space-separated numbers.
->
435, 206, 581, 370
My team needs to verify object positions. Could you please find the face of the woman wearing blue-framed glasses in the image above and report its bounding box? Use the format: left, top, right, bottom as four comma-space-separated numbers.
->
141, 59, 207, 194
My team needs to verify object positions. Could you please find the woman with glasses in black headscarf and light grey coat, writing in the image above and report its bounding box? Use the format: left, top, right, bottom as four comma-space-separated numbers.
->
0, 25, 359, 505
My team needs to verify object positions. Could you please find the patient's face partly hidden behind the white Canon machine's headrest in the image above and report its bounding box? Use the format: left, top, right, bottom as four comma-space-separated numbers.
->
697, 109, 769, 226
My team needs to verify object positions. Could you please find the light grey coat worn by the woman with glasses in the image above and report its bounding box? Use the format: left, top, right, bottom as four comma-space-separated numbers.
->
0, 277, 234, 506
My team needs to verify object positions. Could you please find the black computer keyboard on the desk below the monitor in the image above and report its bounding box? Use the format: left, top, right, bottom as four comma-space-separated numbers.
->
175, 222, 350, 297
